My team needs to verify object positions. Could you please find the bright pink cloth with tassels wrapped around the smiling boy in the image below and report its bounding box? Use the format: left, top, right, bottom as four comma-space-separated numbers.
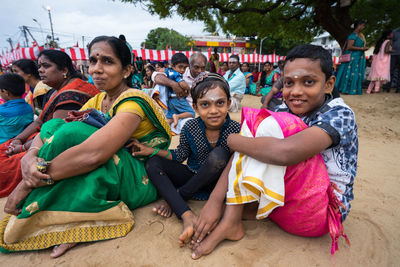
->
242, 107, 348, 254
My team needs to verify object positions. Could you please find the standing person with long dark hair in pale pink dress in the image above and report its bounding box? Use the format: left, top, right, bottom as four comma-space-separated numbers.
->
367, 31, 393, 94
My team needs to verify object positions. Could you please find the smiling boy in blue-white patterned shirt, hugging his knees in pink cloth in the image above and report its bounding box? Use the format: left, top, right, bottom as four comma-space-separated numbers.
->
191, 45, 358, 259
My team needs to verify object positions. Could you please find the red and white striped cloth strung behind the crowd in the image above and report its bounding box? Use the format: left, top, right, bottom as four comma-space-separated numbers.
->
0, 46, 339, 67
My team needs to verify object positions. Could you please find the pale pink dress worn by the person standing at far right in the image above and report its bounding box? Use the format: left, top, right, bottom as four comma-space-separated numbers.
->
368, 40, 390, 82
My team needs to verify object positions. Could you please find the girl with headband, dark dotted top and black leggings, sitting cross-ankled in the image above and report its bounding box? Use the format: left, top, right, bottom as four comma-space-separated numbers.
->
132, 73, 240, 246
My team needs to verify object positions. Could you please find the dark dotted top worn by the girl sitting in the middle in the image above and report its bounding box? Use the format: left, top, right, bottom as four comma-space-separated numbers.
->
170, 114, 240, 172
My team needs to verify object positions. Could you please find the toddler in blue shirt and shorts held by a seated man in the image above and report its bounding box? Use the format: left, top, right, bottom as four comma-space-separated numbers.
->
160, 53, 196, 131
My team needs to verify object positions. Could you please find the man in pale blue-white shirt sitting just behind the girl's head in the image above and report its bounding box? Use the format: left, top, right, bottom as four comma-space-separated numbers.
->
224, 55, 246, 112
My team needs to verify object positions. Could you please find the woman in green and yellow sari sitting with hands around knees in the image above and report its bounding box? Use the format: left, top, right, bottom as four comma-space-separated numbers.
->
0, 36, 171, 257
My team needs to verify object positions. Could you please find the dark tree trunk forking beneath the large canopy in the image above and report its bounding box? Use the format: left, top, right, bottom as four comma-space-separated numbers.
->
313, 0, 352, 48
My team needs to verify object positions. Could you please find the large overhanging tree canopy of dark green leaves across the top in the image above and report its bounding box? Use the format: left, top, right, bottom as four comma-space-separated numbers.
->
120, 0, 400, 49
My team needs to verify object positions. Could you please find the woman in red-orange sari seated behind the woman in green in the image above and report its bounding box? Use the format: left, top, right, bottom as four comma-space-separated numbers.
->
0, 50, 100, 197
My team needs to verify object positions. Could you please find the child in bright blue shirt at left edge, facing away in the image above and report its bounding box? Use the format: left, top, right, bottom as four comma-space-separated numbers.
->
0, 73, 33, 144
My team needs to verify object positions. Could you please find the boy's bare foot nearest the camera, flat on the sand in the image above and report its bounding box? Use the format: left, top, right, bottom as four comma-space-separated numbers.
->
192, 219, 245, 260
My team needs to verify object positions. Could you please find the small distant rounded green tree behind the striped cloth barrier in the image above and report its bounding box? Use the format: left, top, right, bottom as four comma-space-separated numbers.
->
142, 28, 191, 50
